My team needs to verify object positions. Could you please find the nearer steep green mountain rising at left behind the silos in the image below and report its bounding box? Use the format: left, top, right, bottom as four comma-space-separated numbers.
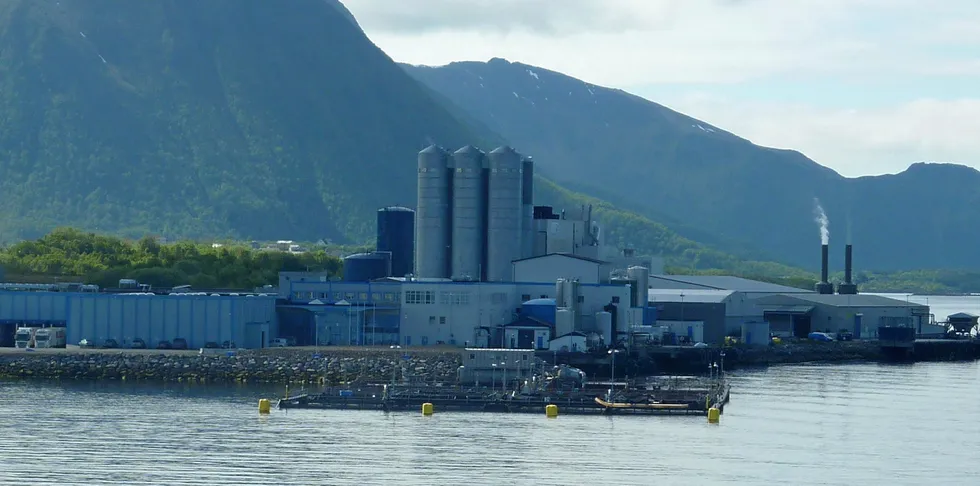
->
0, 0, 796, 275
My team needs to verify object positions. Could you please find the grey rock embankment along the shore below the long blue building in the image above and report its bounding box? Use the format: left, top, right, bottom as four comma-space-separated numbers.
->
0, 350, 461, 385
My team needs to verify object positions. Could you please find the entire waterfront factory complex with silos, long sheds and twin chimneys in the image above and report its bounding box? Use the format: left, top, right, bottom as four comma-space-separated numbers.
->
0, 145, 930, 350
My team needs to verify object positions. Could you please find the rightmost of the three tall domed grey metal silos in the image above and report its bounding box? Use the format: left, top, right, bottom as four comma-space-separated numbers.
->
486, 147, 523, 282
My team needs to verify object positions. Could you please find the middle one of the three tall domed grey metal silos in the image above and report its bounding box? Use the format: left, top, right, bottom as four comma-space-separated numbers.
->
452, 145, 487, 281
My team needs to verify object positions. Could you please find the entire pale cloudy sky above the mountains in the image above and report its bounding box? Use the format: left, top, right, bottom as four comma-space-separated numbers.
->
342, 0, 980, 177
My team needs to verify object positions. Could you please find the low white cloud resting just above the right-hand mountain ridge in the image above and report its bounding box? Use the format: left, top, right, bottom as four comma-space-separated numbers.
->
666, 93, 980, 177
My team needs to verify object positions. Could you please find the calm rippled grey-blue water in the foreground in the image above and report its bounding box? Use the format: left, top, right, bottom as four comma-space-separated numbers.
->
0, 363, 980, 485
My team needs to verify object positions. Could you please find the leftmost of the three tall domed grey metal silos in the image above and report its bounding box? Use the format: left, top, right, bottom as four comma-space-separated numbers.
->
415, 145, 453, 278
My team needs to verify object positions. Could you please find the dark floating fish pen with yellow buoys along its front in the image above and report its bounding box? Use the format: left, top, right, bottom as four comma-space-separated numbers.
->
277, 377, 730, 415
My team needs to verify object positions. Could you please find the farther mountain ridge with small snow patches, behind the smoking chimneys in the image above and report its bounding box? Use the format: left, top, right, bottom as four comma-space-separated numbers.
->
403, 59, 980, 270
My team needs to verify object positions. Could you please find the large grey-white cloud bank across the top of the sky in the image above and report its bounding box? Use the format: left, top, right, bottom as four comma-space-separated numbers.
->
345, 0, 980, 86
